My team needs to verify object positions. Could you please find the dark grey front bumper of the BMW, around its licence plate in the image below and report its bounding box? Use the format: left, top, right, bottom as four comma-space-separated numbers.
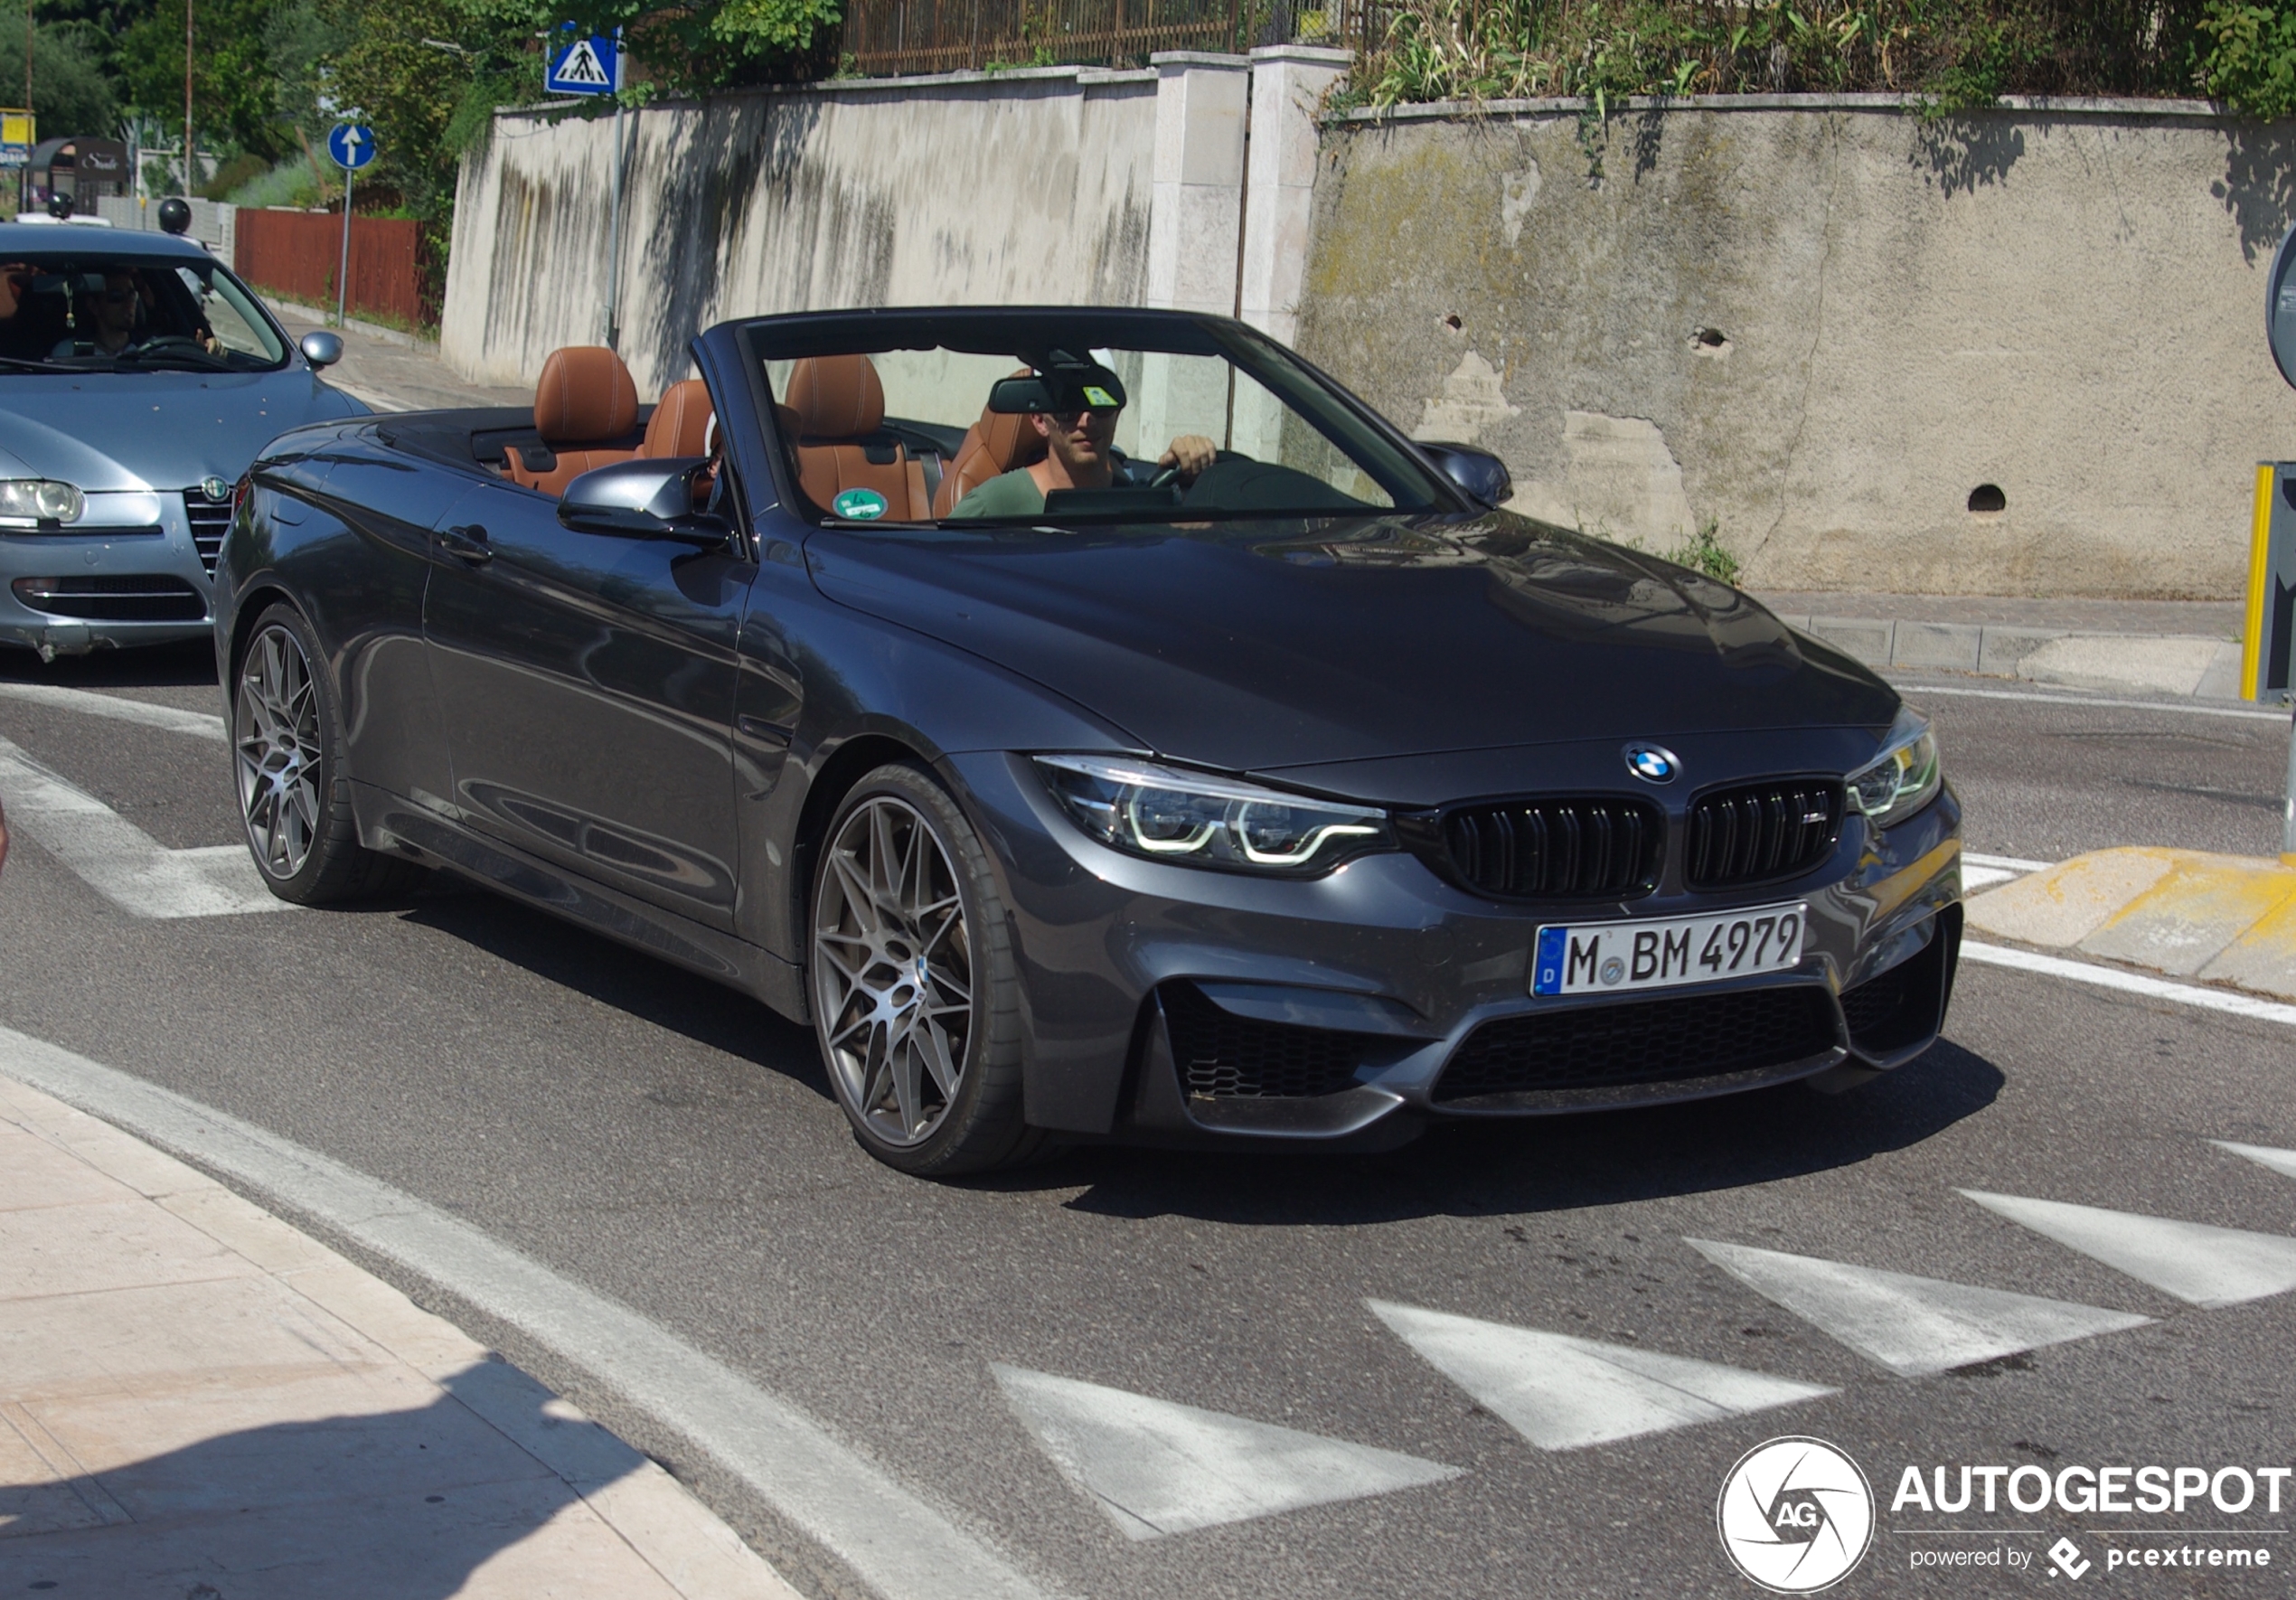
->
951, 755, 1961, 1145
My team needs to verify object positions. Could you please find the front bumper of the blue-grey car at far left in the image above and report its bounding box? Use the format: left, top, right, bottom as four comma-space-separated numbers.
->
0, 491, 227, 656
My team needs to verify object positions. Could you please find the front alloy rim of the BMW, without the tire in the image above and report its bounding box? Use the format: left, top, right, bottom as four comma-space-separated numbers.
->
813, 795, 974, 1145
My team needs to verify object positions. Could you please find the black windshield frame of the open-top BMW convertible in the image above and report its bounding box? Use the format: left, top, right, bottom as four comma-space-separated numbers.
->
732, 306, 1485, 532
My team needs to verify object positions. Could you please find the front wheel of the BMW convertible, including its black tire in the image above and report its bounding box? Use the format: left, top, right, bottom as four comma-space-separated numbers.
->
806, 765, 1042, 1178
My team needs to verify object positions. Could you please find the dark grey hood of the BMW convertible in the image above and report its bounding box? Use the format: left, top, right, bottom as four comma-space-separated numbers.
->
806, 512, 1896, 771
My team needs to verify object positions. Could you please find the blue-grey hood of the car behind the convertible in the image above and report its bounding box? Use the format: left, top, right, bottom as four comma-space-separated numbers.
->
0, 362, 362, 491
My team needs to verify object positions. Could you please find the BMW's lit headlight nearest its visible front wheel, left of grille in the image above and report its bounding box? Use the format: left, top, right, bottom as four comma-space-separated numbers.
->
1036, 755, 1396, 877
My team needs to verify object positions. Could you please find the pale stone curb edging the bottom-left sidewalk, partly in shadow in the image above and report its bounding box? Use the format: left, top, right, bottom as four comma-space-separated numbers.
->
0, 1060, 799, 1600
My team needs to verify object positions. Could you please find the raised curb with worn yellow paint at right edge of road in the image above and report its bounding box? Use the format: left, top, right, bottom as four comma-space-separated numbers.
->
1965, 847, 2296, 1001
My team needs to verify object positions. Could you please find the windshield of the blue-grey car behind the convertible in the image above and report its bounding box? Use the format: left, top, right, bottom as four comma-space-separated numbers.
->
0, 250, 287, 372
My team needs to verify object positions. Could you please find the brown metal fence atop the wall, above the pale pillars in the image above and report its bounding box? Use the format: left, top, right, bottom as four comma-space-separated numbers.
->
842, 0, 1350, 78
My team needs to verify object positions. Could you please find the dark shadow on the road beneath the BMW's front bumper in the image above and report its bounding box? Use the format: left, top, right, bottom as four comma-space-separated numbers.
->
1033, 1042, 2004, 1228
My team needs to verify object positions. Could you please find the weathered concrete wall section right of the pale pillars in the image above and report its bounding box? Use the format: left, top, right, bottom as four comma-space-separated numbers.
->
1297, 99, 2296, 597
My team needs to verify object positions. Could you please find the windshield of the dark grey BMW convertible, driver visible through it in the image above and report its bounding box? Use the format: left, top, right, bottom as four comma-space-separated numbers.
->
753, 312, 1455, 526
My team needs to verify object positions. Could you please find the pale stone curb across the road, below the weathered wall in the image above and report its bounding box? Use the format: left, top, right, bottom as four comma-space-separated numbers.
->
1780, 613, 2241, 701
